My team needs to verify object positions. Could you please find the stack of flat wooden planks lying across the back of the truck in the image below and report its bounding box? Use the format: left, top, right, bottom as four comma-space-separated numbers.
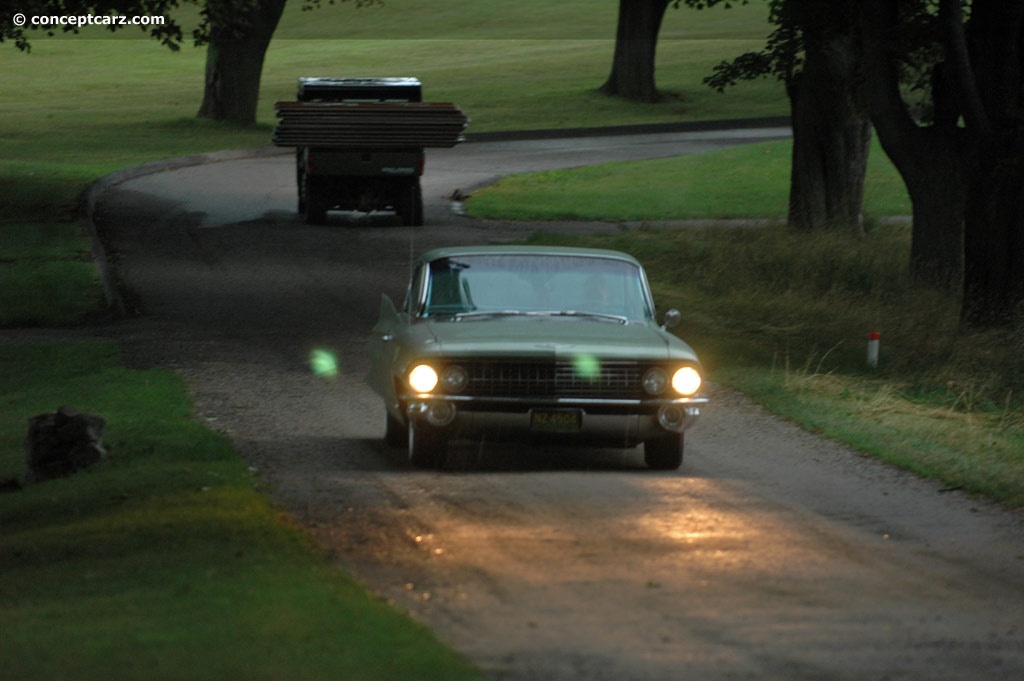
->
273, 101, 469, 148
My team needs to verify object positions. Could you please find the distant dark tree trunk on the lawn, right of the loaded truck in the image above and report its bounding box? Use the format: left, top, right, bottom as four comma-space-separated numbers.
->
601, 0, 670, 102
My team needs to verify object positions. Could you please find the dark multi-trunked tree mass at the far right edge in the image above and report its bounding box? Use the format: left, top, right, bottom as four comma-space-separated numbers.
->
860, 0, 1024, 326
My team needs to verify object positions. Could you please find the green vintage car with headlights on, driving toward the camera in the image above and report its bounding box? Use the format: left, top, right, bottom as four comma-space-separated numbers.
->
367, 246, 708, 470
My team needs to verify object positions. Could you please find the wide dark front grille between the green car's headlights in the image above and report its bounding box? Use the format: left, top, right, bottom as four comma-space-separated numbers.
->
454, 359, 643, 399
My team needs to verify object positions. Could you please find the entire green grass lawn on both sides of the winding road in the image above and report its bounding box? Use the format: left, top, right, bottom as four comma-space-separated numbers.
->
0, 0, 1024, 680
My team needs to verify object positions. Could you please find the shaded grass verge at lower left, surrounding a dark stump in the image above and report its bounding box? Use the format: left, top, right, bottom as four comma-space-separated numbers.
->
0, 342, 478, 681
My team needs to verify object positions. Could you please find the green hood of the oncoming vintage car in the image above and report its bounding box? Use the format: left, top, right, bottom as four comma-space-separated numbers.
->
409, 316, 696, 361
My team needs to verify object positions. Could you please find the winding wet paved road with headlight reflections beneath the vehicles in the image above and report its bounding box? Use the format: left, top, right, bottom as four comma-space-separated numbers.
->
90, 130, 1024, 681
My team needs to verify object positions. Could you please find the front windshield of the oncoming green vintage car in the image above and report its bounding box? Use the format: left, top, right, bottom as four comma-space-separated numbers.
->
423, 254, 651, 321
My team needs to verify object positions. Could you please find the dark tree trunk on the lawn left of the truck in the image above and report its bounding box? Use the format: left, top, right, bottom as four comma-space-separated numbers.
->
199, 0, 287, 125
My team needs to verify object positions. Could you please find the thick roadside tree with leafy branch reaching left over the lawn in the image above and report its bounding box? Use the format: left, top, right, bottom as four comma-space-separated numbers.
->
687, 0, 871, 232
